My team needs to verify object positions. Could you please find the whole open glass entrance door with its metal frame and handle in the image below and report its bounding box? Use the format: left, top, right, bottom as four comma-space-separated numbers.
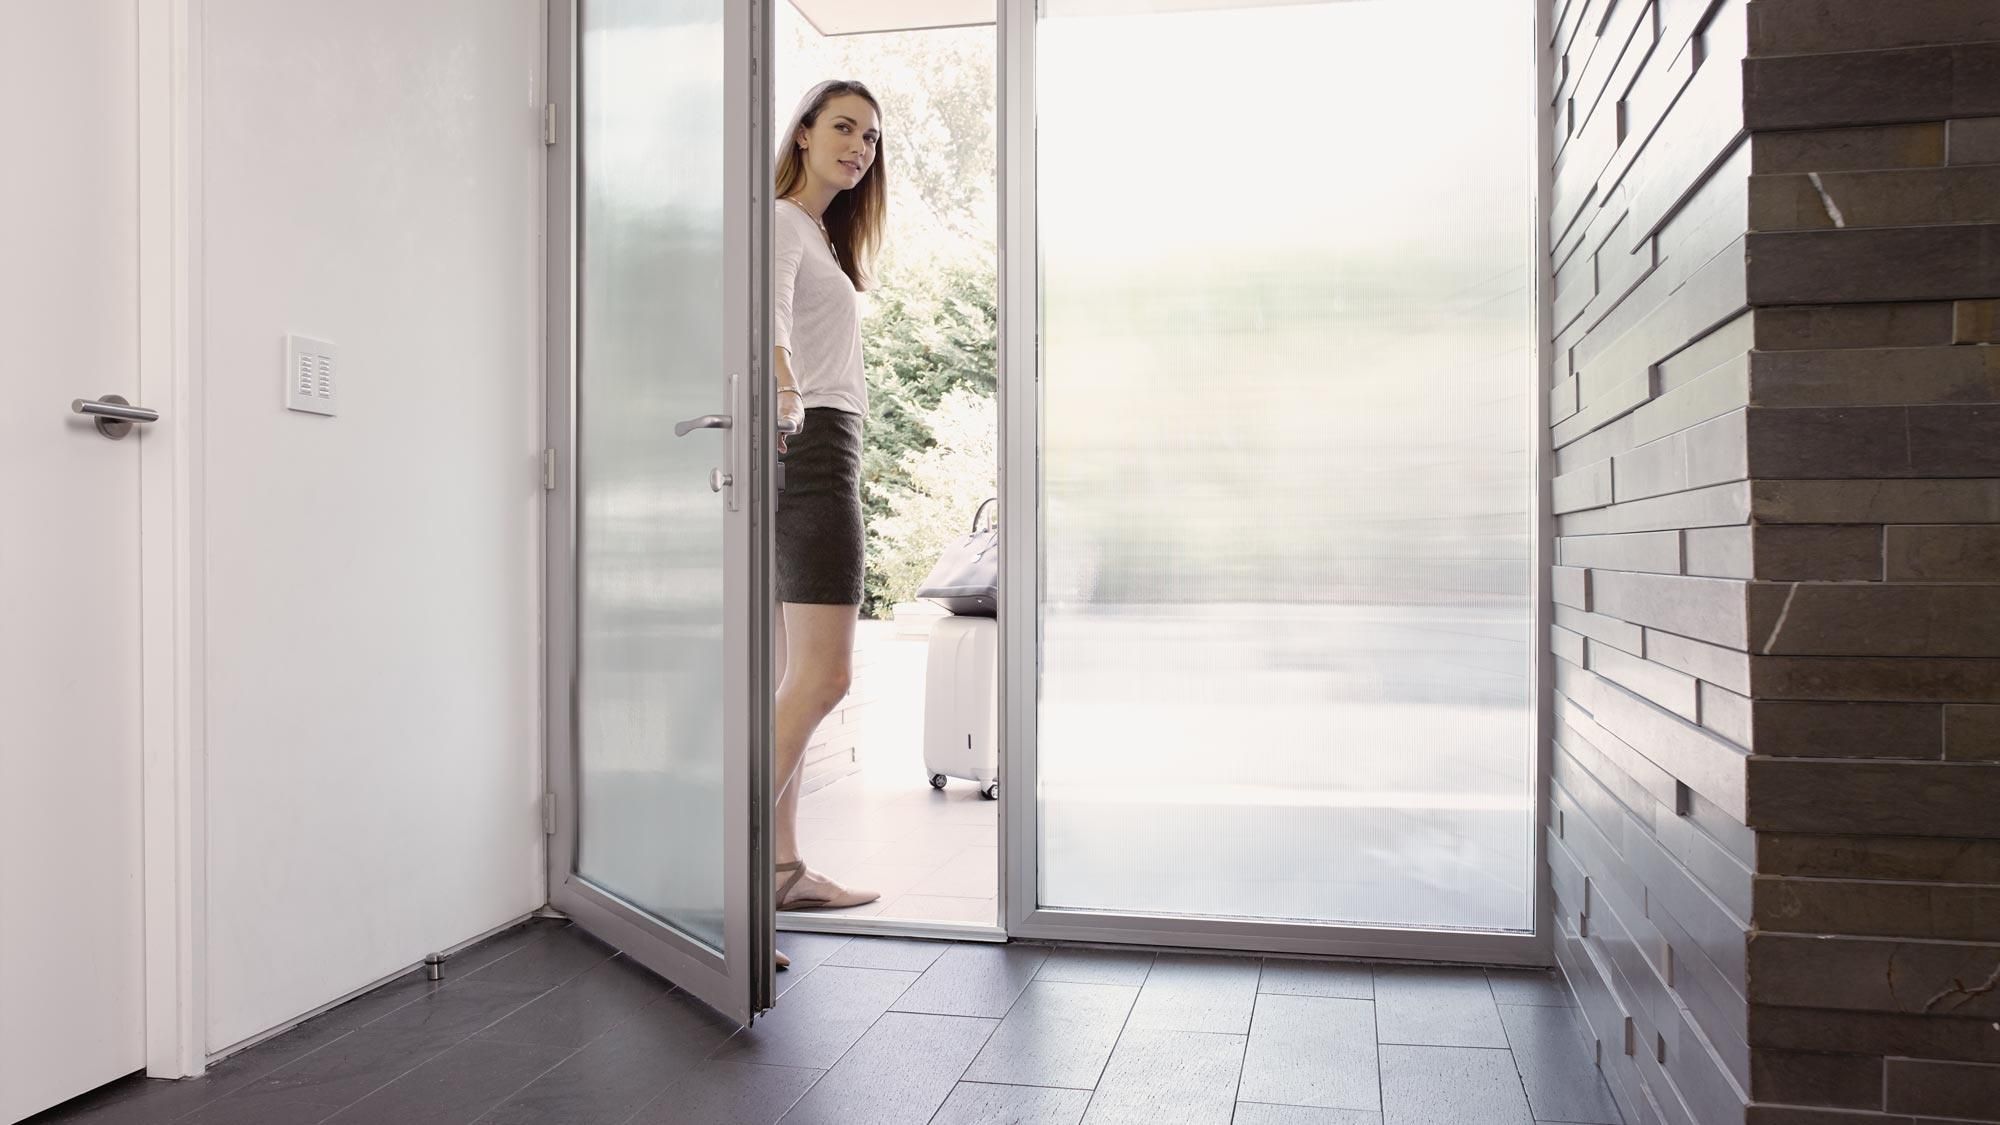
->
544, 0, 772, 1023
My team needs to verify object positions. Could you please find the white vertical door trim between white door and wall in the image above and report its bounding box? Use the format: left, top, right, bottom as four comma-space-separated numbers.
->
134, 0, 208, 1079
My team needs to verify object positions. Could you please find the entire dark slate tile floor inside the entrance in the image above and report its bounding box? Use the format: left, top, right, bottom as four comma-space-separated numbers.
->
32, 919, 1620, 1125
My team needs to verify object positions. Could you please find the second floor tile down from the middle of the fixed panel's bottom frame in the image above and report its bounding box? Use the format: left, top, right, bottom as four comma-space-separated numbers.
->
1236, 995, 1382, 1111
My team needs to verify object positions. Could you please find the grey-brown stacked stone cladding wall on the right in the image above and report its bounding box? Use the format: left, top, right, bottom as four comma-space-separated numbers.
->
1546, 0, 2000, 1125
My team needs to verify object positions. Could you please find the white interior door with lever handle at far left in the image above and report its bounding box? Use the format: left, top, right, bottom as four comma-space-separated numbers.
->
0, 0, 146, 1121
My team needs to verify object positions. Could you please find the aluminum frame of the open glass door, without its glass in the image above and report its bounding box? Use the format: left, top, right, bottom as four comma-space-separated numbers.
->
542, 0, 782, 1025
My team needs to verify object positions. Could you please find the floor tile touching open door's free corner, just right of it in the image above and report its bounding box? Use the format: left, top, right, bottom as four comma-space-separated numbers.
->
714, 965, 916, 1071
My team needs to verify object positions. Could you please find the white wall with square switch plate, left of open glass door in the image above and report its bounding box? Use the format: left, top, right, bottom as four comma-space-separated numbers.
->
198, 0, 544, 1051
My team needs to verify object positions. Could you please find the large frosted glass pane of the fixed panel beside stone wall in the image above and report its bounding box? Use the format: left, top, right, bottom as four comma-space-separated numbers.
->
1038, 0, 1536, 931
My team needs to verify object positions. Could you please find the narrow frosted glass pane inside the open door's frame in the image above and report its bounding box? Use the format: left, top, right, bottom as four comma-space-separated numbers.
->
576, 0, 724, 951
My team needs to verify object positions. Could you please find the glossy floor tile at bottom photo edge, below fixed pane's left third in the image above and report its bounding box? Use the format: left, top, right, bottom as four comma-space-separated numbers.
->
1084, 1027, 1246, 1125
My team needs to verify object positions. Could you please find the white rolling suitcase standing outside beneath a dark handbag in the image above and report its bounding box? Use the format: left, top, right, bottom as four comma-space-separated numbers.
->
924, 617, 1000, 799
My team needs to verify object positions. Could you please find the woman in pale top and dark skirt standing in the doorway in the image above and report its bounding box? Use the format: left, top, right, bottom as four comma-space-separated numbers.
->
770, 80, 888, 944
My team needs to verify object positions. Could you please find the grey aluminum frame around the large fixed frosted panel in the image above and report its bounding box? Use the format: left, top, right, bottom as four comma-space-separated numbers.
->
998, 0, 1554, 965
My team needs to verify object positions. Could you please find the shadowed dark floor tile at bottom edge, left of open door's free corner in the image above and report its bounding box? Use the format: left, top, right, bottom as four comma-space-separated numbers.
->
480, 993, 736, 1125
